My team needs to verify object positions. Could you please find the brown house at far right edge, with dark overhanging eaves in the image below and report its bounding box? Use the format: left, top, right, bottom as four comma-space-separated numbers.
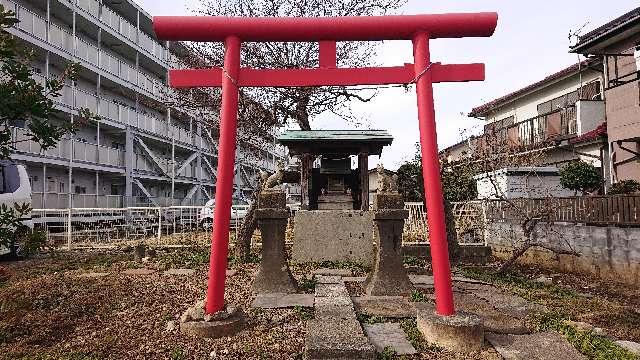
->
571, 8, 640, 182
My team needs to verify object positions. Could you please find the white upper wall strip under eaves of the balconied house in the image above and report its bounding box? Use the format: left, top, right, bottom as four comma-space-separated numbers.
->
486, 70, 602, 123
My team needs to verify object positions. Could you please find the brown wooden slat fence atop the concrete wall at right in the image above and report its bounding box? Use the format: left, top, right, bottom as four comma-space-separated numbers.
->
487, 195, 640, 226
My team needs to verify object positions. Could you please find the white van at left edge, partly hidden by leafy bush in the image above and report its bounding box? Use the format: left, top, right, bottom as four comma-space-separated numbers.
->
0, 160, 33, 256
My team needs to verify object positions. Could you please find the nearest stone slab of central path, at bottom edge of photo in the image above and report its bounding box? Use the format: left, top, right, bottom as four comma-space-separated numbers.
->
305, 319, 376, 360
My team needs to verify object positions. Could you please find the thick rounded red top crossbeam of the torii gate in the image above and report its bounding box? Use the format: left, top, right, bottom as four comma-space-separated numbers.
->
153, 13, 498, 42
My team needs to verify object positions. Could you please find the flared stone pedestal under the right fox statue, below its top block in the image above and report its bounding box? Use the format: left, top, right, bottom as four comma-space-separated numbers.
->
365, 209, 413, 296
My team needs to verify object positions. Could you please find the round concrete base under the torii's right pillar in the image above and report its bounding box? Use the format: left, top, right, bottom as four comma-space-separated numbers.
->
417, 304, 484, 354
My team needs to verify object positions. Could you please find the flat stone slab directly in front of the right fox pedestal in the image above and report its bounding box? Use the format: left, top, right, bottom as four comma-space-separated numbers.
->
352, 296, 416, 318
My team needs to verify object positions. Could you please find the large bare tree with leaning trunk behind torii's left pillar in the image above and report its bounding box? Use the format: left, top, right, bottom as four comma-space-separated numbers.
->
174, 0, 406, 259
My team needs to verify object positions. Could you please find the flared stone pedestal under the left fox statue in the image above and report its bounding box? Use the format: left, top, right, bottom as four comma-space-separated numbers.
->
253, 191, 298, 294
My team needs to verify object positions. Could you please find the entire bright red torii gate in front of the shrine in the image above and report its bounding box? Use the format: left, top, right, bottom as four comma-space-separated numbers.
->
153, 13, 498, 316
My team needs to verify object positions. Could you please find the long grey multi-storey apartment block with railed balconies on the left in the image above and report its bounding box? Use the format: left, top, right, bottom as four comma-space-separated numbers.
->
0, 0, 285, 209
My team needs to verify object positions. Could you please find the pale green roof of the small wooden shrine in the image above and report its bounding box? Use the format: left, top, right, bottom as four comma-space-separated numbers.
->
278, 130, 393, 155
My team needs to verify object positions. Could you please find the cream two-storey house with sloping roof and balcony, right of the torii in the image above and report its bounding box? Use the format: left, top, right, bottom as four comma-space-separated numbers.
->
441, 59, 609, 183
